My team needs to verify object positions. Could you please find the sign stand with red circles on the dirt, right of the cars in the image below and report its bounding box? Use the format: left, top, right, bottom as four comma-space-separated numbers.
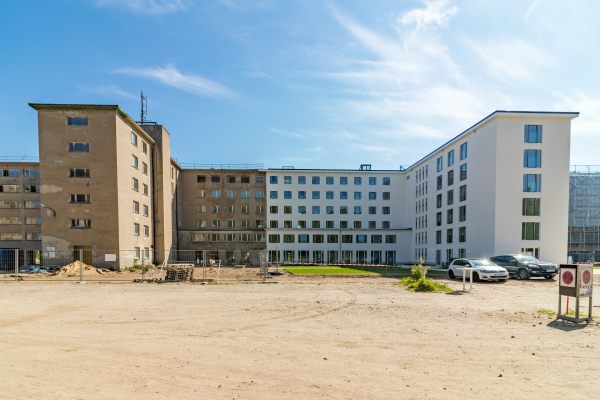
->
556, 264, 594, 323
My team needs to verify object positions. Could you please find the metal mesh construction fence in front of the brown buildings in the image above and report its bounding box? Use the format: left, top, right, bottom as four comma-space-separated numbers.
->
0, 249, 269, 283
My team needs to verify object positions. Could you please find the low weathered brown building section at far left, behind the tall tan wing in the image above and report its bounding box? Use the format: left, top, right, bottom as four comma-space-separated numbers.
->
0, 161, 42, 269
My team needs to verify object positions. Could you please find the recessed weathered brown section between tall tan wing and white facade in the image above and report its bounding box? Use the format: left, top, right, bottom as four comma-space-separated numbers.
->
178, 168, 266, 264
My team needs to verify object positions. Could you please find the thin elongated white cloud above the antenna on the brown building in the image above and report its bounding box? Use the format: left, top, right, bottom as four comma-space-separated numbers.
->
114, 65, 236, 98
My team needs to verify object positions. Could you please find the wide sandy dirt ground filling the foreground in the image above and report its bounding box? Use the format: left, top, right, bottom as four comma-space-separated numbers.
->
0, 276, 600, 400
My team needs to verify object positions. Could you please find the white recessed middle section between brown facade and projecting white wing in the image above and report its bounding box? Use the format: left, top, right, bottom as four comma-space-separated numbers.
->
266, 165, 411, 264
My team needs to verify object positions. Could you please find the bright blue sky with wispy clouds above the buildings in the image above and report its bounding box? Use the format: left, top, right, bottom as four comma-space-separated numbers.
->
0, 0, 600, 169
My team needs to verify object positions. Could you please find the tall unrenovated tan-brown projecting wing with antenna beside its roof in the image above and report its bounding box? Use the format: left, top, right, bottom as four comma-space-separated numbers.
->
30, 104, 174, 267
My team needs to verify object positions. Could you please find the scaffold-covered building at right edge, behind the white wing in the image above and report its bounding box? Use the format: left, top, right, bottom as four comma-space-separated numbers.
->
569, 165, 600, 263
